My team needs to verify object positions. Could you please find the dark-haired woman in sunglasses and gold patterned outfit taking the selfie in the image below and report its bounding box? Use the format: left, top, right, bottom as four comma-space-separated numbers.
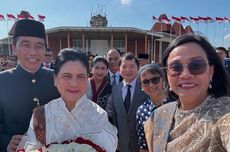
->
145, 35, 230, 152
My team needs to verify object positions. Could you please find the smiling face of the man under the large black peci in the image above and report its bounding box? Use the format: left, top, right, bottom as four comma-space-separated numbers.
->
12, 36, 45, 73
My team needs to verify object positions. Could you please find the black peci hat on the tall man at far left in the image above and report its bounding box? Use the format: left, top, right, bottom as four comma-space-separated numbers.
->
13, 19, 46, 40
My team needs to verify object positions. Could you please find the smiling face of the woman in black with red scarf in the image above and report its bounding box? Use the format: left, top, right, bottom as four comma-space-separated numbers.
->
92, 62, 108, 80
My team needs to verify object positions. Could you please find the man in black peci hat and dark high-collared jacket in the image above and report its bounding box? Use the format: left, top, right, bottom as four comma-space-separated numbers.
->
0, 19, 60, 152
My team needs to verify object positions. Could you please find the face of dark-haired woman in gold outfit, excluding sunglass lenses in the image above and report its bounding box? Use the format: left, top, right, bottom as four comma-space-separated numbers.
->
167, 42, 214, 109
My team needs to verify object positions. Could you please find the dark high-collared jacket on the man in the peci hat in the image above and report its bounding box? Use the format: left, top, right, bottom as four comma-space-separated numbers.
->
0, 65, 60, 152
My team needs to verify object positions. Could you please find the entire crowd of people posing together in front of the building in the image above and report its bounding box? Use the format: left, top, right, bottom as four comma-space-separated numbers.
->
0, 20, 230, 152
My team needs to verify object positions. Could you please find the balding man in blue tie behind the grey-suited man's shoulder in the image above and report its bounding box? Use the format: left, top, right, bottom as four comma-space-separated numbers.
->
105, 48, 123, 86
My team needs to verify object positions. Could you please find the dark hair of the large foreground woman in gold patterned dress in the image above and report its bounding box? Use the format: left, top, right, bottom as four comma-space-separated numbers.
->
162, 34, 230, 98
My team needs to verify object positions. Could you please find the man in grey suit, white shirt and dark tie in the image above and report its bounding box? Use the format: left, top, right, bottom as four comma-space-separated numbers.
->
110, 53, 147, 152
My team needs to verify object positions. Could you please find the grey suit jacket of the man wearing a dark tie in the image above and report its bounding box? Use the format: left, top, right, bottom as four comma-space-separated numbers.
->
111, 79, 147, 152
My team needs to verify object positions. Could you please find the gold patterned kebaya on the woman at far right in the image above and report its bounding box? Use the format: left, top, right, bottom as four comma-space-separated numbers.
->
145, 96, 230, 152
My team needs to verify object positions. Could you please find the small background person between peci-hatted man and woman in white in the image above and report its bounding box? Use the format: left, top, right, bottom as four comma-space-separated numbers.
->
42, 48, 54, 69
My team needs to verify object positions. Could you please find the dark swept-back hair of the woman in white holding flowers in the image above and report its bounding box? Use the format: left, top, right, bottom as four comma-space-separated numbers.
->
54, 48, 89, 75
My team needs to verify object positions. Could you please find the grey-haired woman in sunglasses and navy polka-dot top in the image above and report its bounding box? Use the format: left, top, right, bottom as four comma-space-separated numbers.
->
136, 64, 172, 152
